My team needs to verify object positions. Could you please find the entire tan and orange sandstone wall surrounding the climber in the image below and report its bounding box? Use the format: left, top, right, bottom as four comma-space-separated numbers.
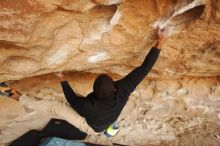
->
0, 0, 220, 145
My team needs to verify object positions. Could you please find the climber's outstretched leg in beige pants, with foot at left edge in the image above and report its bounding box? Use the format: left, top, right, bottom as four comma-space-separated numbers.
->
0, 81, 96, 135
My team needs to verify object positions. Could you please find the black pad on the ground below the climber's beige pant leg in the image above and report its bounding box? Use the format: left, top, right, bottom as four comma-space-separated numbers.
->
9, 119, 87, 146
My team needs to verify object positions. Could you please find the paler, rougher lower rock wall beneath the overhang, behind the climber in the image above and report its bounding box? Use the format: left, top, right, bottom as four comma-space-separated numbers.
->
0, 73, 220, 146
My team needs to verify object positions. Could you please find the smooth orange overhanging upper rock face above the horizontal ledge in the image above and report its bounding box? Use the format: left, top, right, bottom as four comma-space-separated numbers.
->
0, 0, 220, 80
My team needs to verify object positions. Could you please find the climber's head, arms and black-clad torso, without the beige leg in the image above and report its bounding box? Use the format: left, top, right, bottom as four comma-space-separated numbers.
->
57, 26, 164, 135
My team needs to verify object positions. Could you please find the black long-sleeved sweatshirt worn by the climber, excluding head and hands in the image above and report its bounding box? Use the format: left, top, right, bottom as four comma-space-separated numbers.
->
61, 47, 160, 132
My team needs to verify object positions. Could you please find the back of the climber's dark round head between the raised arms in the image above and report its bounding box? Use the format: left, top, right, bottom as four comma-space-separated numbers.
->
93, 74, 115, 99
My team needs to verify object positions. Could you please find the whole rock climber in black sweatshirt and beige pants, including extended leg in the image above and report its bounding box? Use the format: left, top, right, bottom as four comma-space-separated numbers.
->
1, 28, 164, 136
